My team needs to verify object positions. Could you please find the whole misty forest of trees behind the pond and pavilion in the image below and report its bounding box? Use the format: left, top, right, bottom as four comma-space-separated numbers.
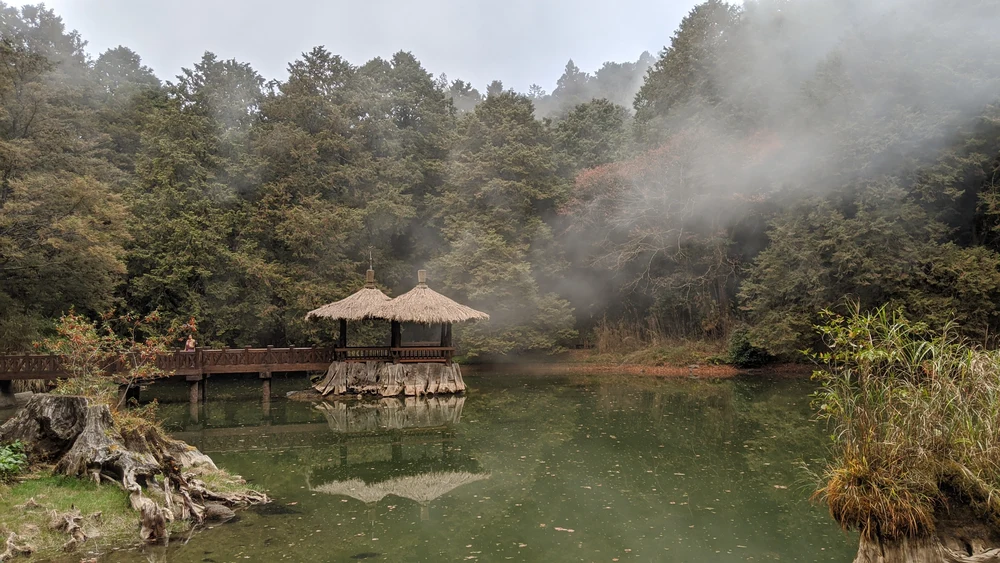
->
0, 0, 1000, 360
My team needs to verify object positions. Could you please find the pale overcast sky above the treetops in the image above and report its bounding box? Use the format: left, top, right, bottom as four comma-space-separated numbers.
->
37, 0, 696, 91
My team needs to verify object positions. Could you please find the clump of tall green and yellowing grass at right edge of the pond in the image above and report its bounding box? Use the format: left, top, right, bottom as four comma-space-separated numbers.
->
811, 306, 1000, 540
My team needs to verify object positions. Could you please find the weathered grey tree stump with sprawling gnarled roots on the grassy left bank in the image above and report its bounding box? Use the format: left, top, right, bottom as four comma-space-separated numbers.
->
0, 395, 268, 549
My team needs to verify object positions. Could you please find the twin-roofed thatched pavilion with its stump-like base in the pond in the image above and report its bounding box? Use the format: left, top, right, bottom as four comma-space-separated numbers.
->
306, 270, 490, 396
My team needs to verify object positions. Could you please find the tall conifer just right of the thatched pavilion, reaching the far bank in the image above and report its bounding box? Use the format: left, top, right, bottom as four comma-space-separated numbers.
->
433, 90, 574, 354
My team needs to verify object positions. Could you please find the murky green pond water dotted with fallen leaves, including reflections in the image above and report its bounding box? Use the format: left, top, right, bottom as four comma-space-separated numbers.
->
5, 372, 857, 562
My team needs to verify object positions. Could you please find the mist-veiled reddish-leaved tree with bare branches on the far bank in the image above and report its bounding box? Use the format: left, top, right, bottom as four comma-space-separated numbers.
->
562, 128, 774, 336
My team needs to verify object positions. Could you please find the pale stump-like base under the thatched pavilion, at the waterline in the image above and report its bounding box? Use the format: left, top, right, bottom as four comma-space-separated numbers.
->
313, 362, 465, 397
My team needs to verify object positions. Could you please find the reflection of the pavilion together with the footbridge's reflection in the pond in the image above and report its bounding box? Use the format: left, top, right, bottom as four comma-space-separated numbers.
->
174, 395, 489, 519
